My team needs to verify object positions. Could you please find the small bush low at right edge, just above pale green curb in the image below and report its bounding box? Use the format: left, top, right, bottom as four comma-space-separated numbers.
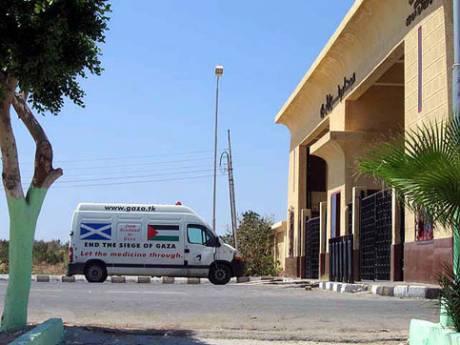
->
439, 267, 460, 332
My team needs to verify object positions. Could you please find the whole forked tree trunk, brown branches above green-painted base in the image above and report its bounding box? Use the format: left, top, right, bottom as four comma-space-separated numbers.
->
0, 84, 62, 331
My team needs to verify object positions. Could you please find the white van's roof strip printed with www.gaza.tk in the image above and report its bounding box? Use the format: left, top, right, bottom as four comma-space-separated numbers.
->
76, 203, 196, 215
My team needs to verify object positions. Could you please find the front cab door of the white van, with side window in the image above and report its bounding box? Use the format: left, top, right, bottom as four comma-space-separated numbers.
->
185, 224, 216, 277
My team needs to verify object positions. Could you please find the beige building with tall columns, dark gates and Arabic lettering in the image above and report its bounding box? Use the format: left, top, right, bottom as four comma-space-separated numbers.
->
275, 0, 453, 282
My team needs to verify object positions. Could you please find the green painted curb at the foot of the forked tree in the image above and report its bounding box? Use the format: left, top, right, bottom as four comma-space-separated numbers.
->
9, 318, 64, 345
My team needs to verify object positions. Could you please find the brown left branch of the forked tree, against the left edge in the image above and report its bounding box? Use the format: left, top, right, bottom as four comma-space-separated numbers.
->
0, 73, 24, 198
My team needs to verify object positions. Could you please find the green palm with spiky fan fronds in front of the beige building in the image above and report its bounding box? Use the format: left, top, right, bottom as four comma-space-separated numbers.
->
358, 118, 460, 331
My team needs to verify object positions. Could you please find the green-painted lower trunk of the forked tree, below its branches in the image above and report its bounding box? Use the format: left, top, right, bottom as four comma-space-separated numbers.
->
1, 187, 47, 332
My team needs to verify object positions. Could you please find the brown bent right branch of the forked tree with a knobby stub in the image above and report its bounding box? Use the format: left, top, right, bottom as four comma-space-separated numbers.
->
12, 93, 63, 188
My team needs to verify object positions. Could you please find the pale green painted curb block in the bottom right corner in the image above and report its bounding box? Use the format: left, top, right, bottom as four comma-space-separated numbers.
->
409, 320, 460, 345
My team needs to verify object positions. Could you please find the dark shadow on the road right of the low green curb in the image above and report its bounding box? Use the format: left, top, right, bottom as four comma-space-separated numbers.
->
61, 325, 209, 345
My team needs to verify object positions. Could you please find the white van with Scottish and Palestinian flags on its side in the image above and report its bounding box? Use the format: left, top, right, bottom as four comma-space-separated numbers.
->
67, 203, 243, 285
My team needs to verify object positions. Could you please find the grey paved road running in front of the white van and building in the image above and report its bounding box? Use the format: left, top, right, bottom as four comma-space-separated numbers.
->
0, 282, 438, 344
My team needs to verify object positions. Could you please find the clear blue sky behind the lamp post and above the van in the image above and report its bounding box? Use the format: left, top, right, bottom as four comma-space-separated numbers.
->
0, 0, 353, 240
